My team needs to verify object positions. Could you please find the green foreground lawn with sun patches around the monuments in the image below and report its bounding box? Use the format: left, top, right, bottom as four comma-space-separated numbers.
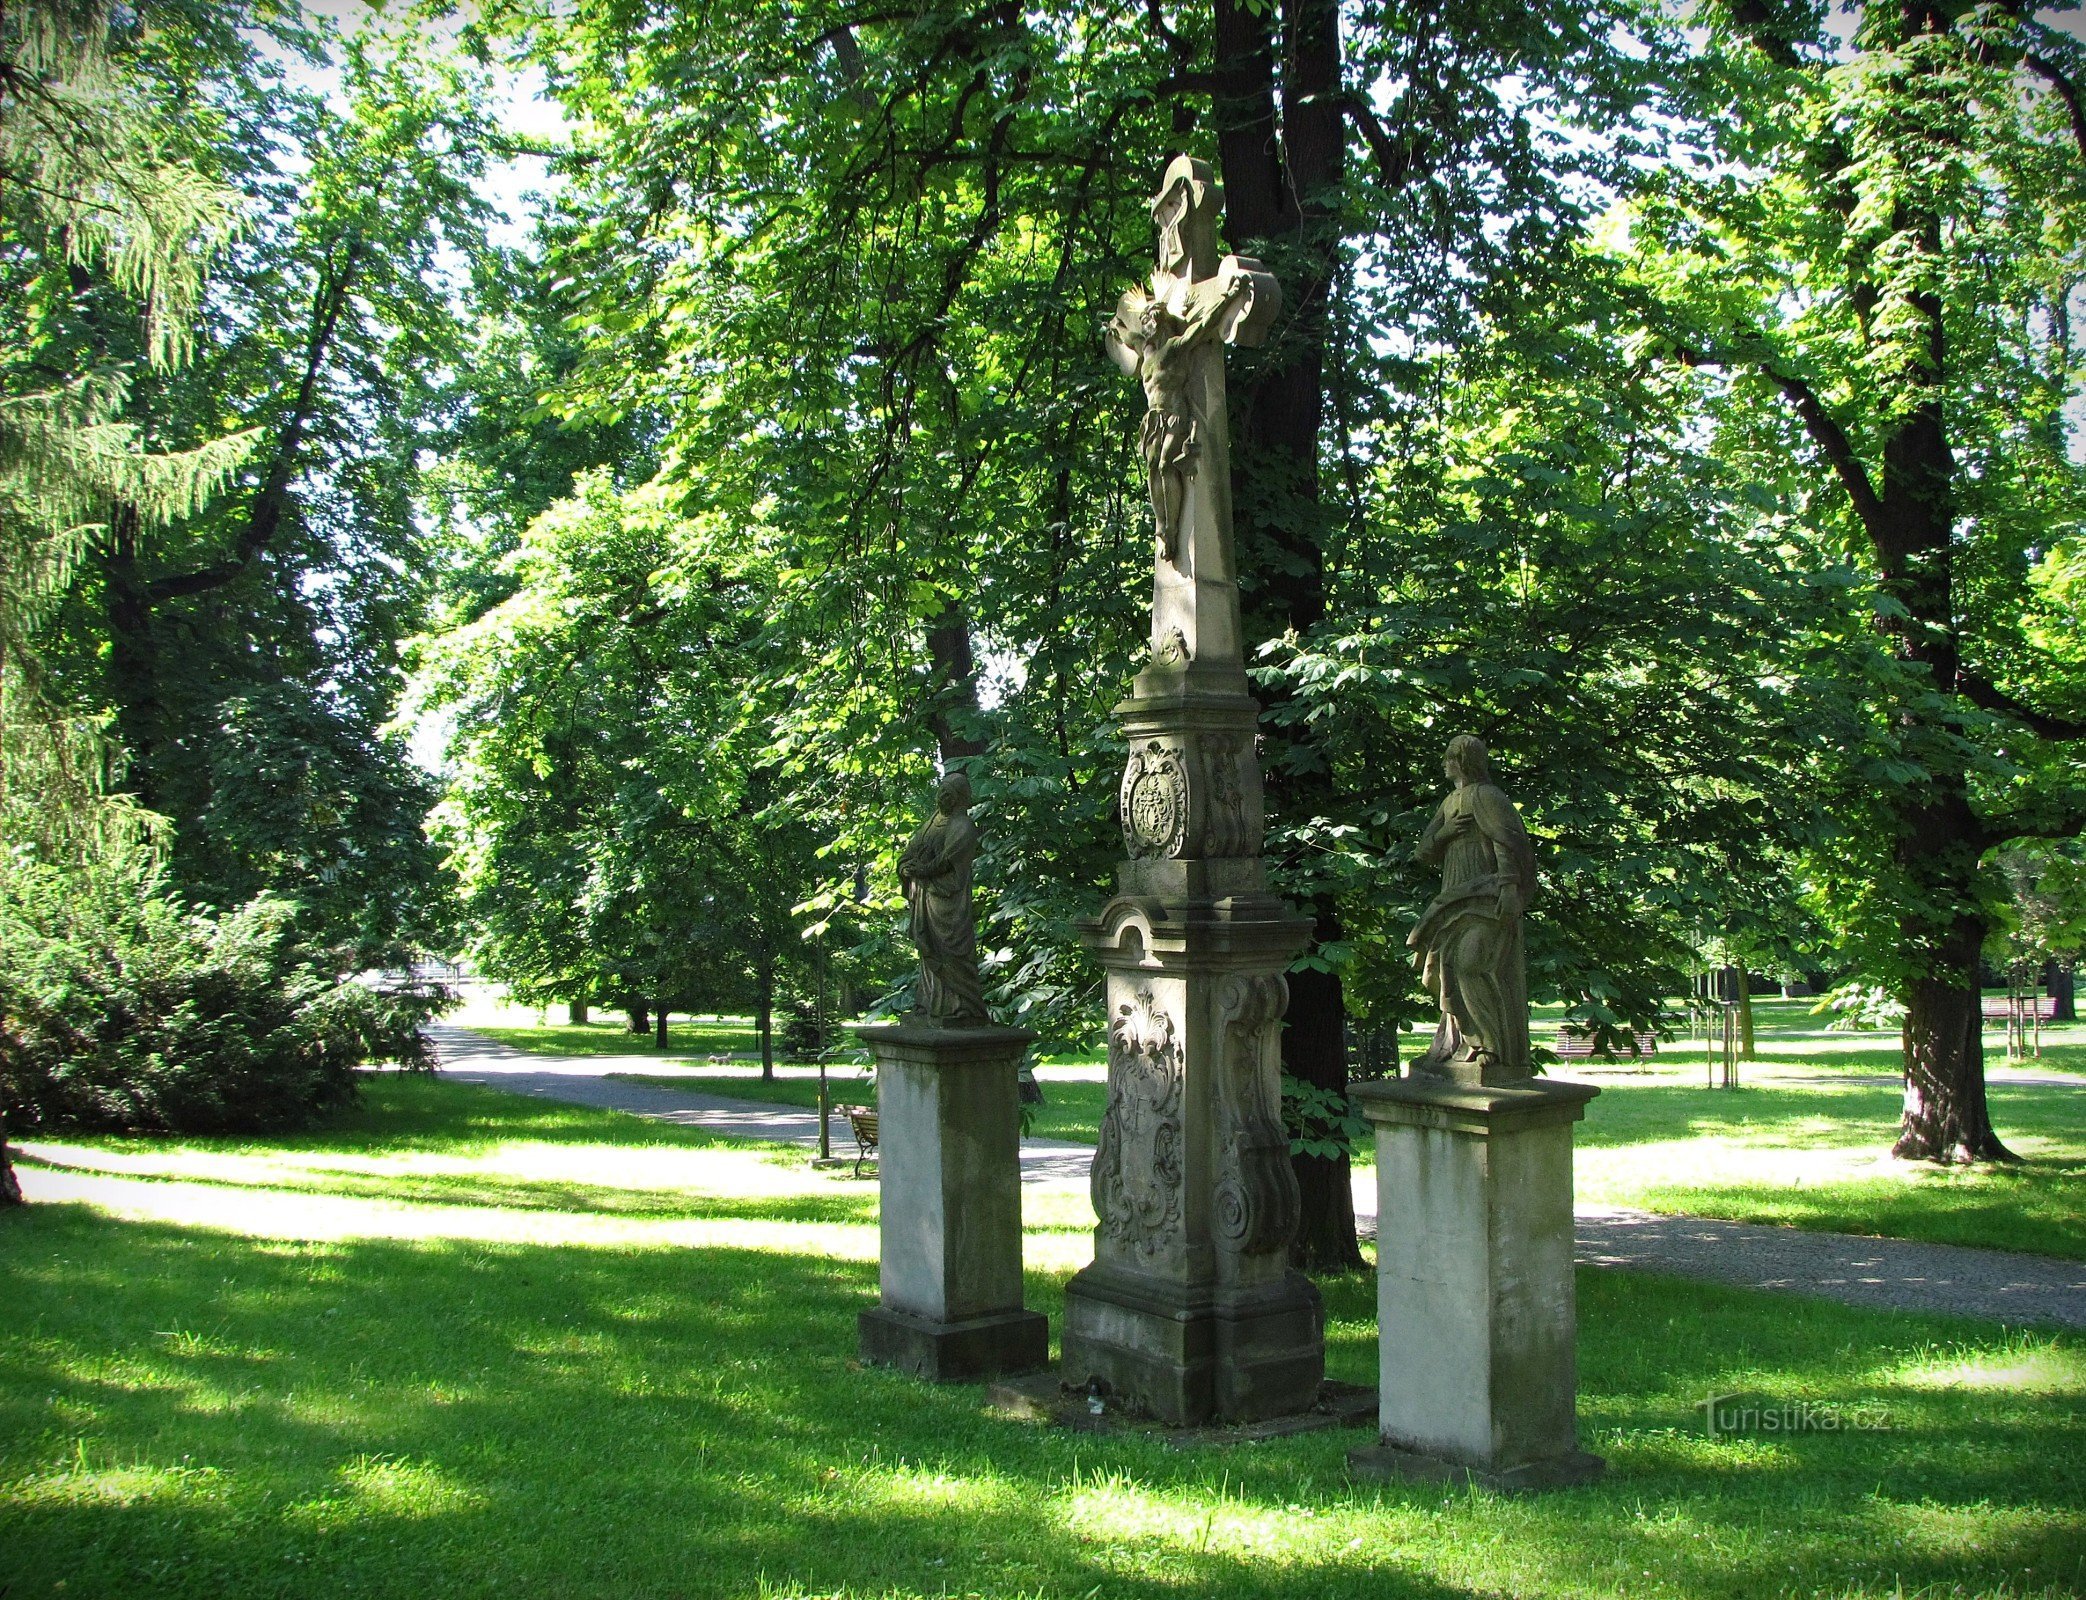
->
0, 1076, 2086, 1600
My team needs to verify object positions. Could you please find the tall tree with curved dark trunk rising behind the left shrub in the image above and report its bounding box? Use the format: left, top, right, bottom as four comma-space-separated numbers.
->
46, 4, 502, 960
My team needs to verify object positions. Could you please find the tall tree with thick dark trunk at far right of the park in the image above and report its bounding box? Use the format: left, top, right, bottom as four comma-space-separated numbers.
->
1635, 0, 2086, 1160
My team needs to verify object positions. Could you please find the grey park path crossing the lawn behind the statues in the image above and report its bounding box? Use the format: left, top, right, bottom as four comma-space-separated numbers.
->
430, 1024, 2086, 1329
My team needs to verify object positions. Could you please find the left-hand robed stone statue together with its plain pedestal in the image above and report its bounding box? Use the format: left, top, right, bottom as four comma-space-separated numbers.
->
857, 772, 1049, 1383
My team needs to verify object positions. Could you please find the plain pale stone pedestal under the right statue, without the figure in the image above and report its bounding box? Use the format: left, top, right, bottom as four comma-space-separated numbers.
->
1354, 1078, 1600, 1487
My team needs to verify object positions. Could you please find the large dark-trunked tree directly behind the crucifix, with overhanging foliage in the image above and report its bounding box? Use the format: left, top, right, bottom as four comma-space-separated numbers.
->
508, 0, 1660, 1266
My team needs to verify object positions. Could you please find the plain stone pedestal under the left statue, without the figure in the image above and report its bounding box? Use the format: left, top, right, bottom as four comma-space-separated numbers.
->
857, 1022, 1049, 1383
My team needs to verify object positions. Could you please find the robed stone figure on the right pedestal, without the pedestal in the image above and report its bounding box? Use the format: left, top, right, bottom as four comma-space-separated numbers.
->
1406, 734, 1535, 1085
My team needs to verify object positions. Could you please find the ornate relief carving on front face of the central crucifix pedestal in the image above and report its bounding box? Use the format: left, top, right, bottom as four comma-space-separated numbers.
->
1093, 987, 1183, 1256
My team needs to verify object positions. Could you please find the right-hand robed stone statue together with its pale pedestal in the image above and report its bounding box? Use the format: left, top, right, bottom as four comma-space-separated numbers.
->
1348, 734, 1602, 1489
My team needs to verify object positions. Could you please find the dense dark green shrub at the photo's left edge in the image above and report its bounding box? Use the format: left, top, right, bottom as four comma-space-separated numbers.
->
0, 868, 446, 1135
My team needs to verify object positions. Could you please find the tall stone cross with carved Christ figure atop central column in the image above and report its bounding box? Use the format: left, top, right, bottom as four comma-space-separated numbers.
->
1106, 156, 1283, 665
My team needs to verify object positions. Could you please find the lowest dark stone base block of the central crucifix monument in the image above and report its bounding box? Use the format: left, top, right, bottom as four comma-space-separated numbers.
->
1064, 1266, 1325, 1427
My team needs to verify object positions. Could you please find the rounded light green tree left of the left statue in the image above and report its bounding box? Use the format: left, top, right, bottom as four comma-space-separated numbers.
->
419, 471, 818, 1045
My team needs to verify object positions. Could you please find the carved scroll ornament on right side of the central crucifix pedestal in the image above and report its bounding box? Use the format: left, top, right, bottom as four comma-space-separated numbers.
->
1214, 972, 1300, 1254
